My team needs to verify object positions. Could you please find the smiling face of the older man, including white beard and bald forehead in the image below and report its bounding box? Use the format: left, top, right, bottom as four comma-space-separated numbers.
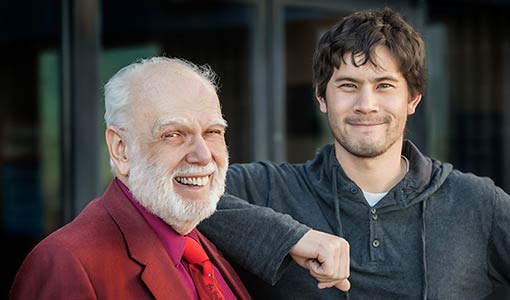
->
115, 64, 228, 234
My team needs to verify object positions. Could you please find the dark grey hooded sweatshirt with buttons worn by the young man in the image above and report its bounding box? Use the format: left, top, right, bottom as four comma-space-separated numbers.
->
199, 141, 510, 300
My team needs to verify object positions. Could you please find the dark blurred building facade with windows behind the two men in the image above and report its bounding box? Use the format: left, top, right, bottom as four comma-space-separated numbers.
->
0, 0, 510, 299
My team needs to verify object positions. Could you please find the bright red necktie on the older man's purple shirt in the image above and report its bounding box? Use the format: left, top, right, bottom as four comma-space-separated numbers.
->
182, 236, 225, 300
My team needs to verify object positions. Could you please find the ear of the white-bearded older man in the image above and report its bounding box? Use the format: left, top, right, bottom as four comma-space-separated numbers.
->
105, 127, 129, 177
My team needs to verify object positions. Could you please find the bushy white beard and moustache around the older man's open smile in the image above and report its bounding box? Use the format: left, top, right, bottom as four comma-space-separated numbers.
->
128, 153, 228, 235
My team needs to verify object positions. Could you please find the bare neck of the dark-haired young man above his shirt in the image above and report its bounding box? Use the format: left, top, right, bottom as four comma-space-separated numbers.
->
335, 142, 408, 193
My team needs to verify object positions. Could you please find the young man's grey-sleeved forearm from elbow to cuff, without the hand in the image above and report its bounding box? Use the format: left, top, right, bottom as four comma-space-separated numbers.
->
199, 194, 310, 285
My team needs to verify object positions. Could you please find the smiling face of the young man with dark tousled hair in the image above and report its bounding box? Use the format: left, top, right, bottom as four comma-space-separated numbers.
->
317, 46, 421, 158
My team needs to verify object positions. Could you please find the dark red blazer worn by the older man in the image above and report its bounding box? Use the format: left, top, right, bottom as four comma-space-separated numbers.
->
10, 182, 251, 300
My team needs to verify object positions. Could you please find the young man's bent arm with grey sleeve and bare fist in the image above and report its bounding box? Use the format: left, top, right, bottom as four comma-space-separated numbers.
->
199, 164, 350, 290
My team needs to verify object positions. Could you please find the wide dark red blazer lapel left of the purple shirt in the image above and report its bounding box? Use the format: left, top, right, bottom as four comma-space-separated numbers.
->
104, 181, 192, 299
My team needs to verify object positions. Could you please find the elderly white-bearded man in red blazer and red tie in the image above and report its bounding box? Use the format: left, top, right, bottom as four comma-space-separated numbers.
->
10, 57, 250, 300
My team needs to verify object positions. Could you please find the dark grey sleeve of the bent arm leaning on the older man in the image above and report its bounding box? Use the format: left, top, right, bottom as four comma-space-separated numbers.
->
199, 163, 310, 285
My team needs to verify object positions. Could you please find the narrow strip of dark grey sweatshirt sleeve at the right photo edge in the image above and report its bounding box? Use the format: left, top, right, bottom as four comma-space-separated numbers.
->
489, 187, 510, 286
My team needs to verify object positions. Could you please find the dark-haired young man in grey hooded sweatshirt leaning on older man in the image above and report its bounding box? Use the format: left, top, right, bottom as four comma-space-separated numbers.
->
199, 9, 510, 300
